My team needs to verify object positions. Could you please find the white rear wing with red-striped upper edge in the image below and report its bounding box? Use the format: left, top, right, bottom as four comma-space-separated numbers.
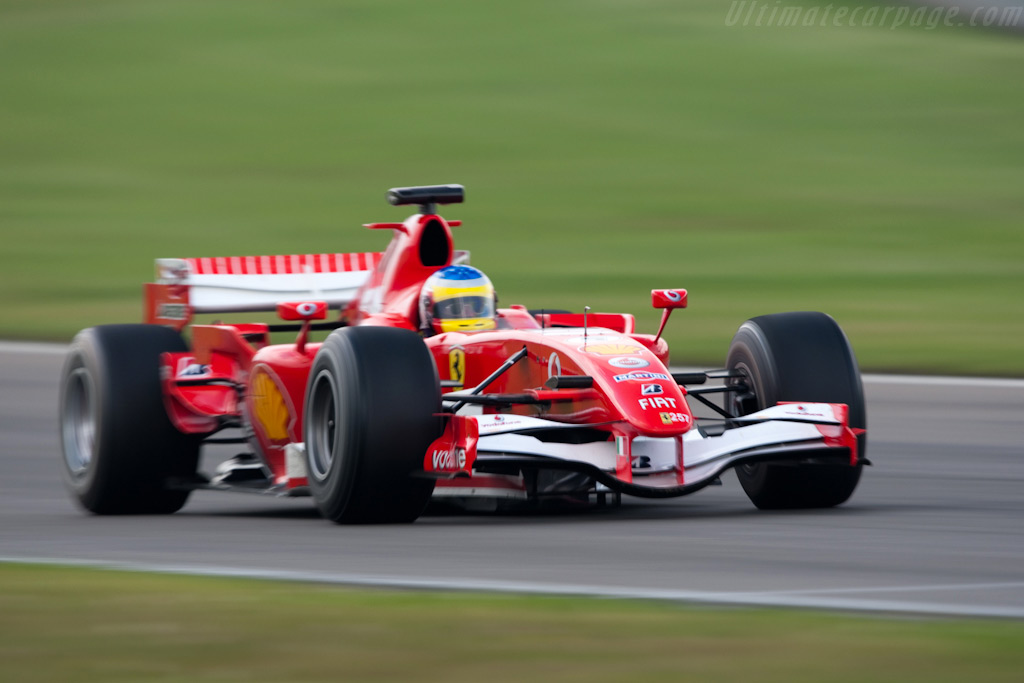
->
145, 252, 383, 330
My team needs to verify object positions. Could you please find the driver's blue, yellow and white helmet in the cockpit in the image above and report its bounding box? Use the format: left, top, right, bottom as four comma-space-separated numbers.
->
420, 265, 497, 333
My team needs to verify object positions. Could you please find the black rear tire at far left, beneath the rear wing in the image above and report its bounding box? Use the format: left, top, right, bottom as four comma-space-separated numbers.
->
59, 325, 200, 514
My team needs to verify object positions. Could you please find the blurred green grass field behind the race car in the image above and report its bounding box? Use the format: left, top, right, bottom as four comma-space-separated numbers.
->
0, 0, 1024, 375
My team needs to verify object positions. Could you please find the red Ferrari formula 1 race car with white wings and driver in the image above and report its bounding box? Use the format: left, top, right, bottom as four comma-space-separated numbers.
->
60, 185, 866, 522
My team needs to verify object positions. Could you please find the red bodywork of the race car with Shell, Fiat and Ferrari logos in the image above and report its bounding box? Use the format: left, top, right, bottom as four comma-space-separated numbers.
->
146, 206, 693, 488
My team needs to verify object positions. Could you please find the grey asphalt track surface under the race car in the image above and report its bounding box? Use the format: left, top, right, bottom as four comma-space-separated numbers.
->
0, 343, 1024, 618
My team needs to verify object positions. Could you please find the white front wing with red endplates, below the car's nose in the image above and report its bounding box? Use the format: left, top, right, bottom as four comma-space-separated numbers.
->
424, 403, 858, 498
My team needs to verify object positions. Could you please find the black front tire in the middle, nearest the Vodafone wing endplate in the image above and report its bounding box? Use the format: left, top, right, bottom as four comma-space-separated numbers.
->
303, 327, 441, 523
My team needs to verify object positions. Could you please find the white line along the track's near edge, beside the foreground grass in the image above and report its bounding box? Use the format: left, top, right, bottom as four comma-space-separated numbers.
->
0, 557, 1024, 620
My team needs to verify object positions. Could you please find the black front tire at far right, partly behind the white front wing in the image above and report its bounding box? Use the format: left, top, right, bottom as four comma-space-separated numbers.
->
726, 312, 867, 510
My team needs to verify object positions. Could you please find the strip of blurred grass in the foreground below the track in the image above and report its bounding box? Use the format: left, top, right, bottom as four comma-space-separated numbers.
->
0, 564, 1024, 683
